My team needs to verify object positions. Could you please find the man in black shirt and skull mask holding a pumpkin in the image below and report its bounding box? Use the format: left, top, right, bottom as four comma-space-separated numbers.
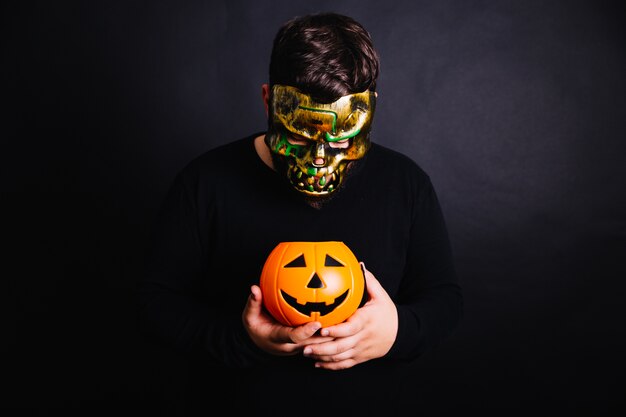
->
140, 13, 462, 416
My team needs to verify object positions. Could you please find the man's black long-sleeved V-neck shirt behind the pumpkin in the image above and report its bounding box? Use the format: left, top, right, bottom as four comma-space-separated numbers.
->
139, 133, 462, 415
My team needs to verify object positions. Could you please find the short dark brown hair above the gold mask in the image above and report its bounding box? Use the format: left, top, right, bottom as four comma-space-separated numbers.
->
269, 13, 379, 102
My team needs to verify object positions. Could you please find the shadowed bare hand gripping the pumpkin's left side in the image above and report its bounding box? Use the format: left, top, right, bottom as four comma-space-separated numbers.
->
242, 285, 333, 356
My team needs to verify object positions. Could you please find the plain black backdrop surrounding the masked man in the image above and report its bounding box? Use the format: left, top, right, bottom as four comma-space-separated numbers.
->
0, 0, 626, 416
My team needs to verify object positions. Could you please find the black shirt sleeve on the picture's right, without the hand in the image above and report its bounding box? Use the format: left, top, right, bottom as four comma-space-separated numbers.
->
387, 176, 463, 360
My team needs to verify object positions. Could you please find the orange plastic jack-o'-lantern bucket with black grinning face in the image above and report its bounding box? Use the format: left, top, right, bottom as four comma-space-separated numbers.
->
260, 241, 365, 327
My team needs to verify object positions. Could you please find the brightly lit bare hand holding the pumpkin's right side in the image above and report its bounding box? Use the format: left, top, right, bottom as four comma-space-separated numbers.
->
303, 262, 398, 370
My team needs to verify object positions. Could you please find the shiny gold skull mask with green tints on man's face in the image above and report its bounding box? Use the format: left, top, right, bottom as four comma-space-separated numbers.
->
265, 85, 376, 197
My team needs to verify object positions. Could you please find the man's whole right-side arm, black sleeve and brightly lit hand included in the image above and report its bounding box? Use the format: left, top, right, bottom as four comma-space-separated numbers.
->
304, 177, 462, 370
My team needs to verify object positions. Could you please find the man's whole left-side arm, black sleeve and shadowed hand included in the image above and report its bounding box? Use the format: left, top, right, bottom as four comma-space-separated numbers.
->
139, 172, 329, 367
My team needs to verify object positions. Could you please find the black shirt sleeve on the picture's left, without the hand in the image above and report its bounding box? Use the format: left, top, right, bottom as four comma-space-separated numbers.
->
138, 169, 271, 368
